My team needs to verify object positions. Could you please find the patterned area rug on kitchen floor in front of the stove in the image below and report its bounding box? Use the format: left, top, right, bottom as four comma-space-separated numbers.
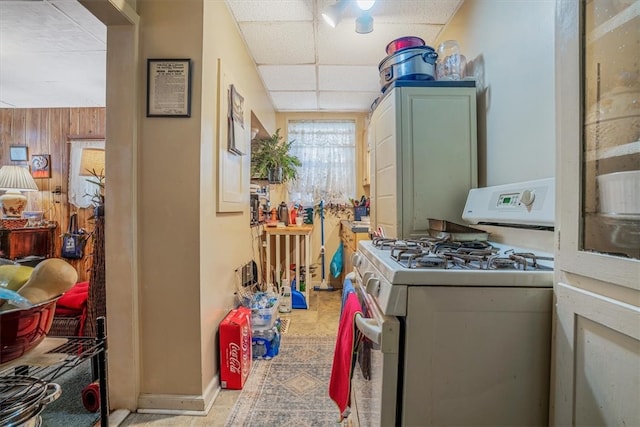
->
225, 335, 340, 427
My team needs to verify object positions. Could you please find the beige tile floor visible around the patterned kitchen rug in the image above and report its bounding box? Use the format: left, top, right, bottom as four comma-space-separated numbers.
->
120, 289, 342, 427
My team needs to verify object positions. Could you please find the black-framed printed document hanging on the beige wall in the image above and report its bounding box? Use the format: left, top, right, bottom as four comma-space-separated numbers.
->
147, 59, 191, 117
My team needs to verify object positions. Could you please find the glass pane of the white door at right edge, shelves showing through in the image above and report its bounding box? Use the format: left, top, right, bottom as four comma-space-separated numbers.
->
581, 0, 640, 259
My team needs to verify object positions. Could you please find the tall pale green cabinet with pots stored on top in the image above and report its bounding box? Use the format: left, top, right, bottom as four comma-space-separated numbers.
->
370, 81, 478, 238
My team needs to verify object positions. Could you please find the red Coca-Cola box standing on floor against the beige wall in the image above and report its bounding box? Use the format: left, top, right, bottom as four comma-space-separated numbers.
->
220, 307, 252, 390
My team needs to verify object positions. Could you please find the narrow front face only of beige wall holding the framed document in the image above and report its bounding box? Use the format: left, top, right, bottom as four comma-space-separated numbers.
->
136, 1, 204, 409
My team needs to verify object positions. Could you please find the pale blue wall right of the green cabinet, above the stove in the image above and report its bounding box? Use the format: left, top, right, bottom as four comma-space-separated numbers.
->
434, 0, 555, 186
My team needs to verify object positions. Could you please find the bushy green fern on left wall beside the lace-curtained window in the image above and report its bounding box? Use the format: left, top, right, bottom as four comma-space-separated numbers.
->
251, 129, 302, 184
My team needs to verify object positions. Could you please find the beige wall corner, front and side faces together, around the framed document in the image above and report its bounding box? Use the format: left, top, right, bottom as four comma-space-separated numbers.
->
138, 1, 274, 410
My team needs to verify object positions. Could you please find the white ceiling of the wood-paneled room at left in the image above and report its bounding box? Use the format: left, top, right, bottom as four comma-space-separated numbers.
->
0, 0, 107, 108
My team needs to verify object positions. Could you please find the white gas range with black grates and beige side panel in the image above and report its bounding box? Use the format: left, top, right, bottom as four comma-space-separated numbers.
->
352, 179, 555, 426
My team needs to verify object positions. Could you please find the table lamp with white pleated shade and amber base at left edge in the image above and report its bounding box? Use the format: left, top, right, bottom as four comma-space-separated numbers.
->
0, 165, 38, 219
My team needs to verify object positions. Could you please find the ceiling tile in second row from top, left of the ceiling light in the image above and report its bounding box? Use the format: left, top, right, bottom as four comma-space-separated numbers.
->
240, 22, 316, 65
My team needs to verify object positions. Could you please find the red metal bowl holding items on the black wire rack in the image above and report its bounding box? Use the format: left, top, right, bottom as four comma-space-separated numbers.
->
0, 295, 62, 363
